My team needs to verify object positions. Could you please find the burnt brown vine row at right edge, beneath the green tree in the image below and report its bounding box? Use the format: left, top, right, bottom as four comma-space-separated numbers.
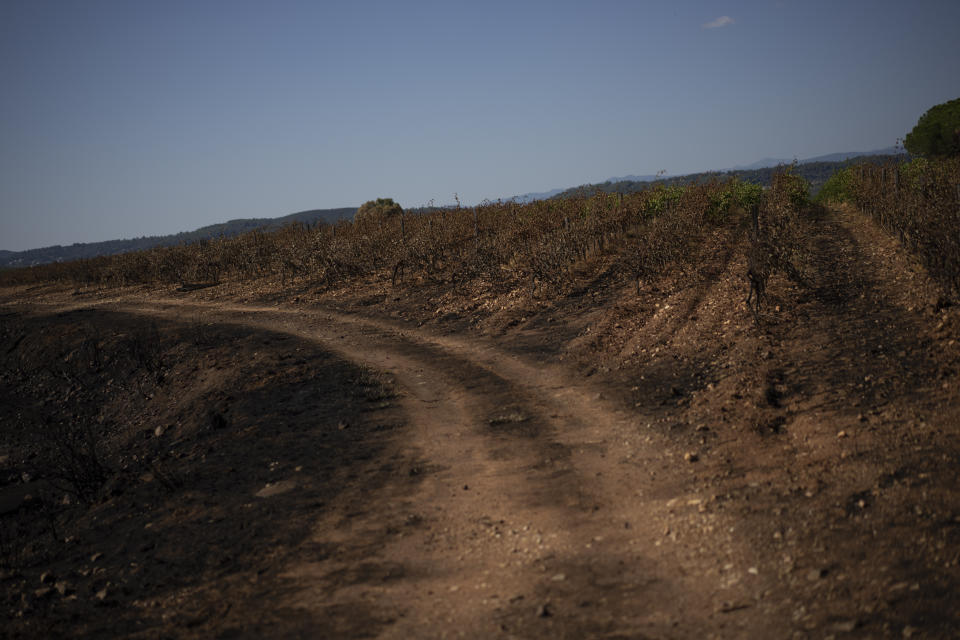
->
847, 158, 960, 299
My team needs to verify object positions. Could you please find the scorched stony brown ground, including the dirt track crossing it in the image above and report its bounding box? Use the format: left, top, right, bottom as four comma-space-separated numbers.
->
0, 210, 960, 638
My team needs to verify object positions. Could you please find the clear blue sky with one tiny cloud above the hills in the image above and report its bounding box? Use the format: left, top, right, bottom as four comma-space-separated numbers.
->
0, 0, 960, 250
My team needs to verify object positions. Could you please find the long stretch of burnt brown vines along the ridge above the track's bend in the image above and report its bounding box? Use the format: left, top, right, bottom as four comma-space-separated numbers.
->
0, 181, 762, 297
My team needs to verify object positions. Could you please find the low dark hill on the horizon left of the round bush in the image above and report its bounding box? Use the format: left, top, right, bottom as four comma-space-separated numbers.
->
0, 207, 357, 268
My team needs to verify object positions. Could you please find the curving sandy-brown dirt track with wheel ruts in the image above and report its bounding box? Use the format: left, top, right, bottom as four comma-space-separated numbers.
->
58, 299, 784, 638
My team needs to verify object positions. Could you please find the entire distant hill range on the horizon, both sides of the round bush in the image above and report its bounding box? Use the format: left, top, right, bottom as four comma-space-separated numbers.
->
0, 147, 904, 268
